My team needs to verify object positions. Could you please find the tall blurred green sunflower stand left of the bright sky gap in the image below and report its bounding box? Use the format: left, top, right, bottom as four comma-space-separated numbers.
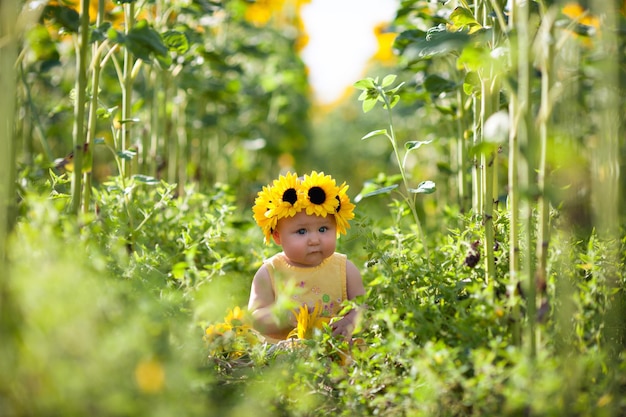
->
17, 1, 310, 198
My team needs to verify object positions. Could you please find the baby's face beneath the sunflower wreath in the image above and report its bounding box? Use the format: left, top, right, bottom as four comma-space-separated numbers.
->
274, 211, 337, 267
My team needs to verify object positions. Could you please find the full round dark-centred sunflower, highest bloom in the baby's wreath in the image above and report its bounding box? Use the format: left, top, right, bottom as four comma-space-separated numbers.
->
300, 171, 339, 217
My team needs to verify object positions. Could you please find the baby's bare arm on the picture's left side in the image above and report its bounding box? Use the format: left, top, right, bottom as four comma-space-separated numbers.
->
248, 265, 296, 336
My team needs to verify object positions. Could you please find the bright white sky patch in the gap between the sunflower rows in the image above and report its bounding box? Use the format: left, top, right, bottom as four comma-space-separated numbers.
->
302, 0, 399, 104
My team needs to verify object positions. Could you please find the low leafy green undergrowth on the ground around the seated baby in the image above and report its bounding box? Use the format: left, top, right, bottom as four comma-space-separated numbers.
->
0, 163, 626, 416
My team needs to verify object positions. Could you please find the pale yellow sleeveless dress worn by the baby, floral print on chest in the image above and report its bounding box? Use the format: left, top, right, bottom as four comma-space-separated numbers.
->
264, 252, 348, 337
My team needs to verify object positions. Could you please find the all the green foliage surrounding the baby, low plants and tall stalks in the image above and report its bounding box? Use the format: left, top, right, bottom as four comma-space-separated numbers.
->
0, 0, 626, 416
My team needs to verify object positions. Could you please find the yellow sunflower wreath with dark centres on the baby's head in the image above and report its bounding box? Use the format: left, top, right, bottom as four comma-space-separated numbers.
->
252, 171, 355, 243
